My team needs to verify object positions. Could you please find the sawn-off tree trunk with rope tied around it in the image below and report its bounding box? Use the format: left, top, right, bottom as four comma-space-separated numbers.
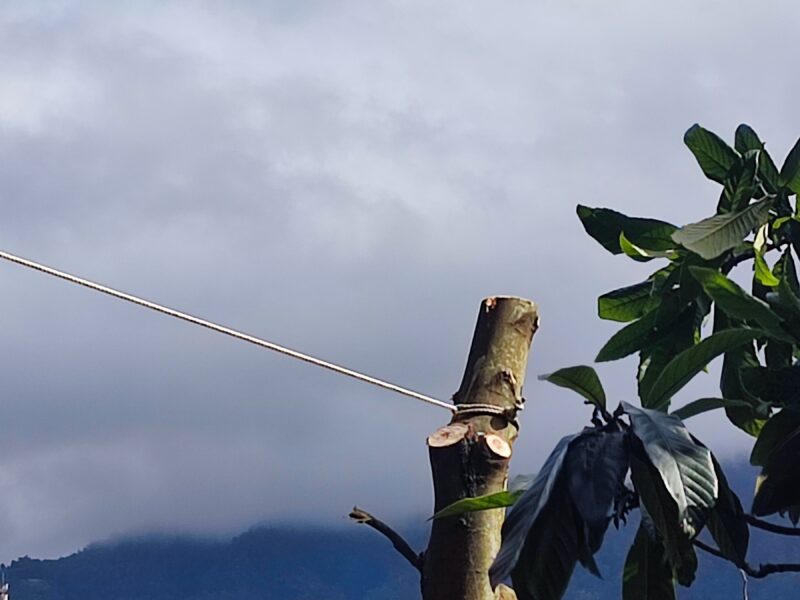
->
422, 297, 538, 600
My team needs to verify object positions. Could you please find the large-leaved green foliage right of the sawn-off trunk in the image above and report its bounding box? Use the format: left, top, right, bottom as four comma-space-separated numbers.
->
438, 125, 800, 600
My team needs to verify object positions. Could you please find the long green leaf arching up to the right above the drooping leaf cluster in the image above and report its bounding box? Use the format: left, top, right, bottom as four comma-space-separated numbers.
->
642, 329, 763, 410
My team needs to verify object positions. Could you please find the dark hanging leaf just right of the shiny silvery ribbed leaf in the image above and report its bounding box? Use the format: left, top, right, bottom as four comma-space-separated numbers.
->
708, 456, 750, 567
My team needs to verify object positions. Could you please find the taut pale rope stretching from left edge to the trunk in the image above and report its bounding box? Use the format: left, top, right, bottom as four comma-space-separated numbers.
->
0, 251, 456, 412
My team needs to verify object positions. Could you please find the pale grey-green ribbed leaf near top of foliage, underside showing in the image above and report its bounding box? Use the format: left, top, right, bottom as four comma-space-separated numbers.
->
672, 200, 772, 259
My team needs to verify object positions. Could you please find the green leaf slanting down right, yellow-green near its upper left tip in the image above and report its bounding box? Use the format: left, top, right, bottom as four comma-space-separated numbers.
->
689, 267, 793, 342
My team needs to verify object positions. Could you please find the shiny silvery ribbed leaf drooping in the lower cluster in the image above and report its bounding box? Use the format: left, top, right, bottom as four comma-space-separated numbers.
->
622, 402, 718, 537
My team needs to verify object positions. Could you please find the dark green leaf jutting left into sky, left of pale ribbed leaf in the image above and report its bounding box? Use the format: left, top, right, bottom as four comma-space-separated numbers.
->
577, 204, 677, 254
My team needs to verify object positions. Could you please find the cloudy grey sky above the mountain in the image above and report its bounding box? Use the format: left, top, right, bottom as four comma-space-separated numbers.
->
0, 0, 800, 562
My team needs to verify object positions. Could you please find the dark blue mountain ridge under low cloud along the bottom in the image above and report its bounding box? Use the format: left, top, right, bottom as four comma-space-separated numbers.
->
1, 465, 800, 600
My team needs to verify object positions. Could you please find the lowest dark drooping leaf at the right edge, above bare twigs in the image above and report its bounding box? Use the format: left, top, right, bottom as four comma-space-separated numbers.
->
752, 427, 800, 517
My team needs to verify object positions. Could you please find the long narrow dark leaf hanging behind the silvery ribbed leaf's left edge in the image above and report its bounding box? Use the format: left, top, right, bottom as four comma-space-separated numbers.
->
630, 445, 697, 586
